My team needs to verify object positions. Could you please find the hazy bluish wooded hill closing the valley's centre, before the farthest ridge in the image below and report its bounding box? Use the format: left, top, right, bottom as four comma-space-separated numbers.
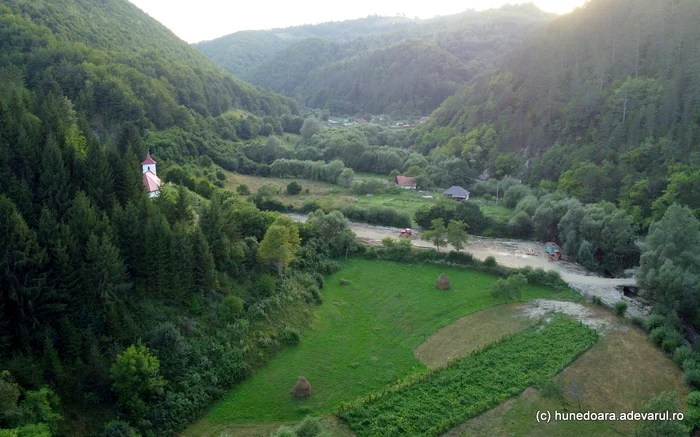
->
200, 4, 551, 115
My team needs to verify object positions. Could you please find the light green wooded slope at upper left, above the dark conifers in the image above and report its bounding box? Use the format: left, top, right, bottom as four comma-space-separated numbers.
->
0, 0, 297, 128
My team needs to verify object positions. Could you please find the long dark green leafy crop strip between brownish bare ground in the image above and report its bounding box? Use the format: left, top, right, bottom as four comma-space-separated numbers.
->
340, 316, 597, 437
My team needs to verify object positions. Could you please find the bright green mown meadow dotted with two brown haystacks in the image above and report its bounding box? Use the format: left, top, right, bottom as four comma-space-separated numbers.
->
184, 259, 578, 436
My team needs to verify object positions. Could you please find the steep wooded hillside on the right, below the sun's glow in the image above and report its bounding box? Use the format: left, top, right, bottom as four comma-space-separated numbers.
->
415, 0, 700, 230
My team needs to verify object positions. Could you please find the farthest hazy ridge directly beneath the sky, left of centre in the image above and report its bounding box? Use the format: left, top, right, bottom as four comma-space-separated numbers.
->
195, 16, 419, 77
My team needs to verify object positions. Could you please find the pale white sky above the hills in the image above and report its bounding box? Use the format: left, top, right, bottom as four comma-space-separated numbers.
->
130, 0, 585, 43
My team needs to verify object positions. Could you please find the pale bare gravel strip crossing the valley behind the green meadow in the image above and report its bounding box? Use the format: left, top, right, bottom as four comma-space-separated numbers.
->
288, 214, 648, 316
